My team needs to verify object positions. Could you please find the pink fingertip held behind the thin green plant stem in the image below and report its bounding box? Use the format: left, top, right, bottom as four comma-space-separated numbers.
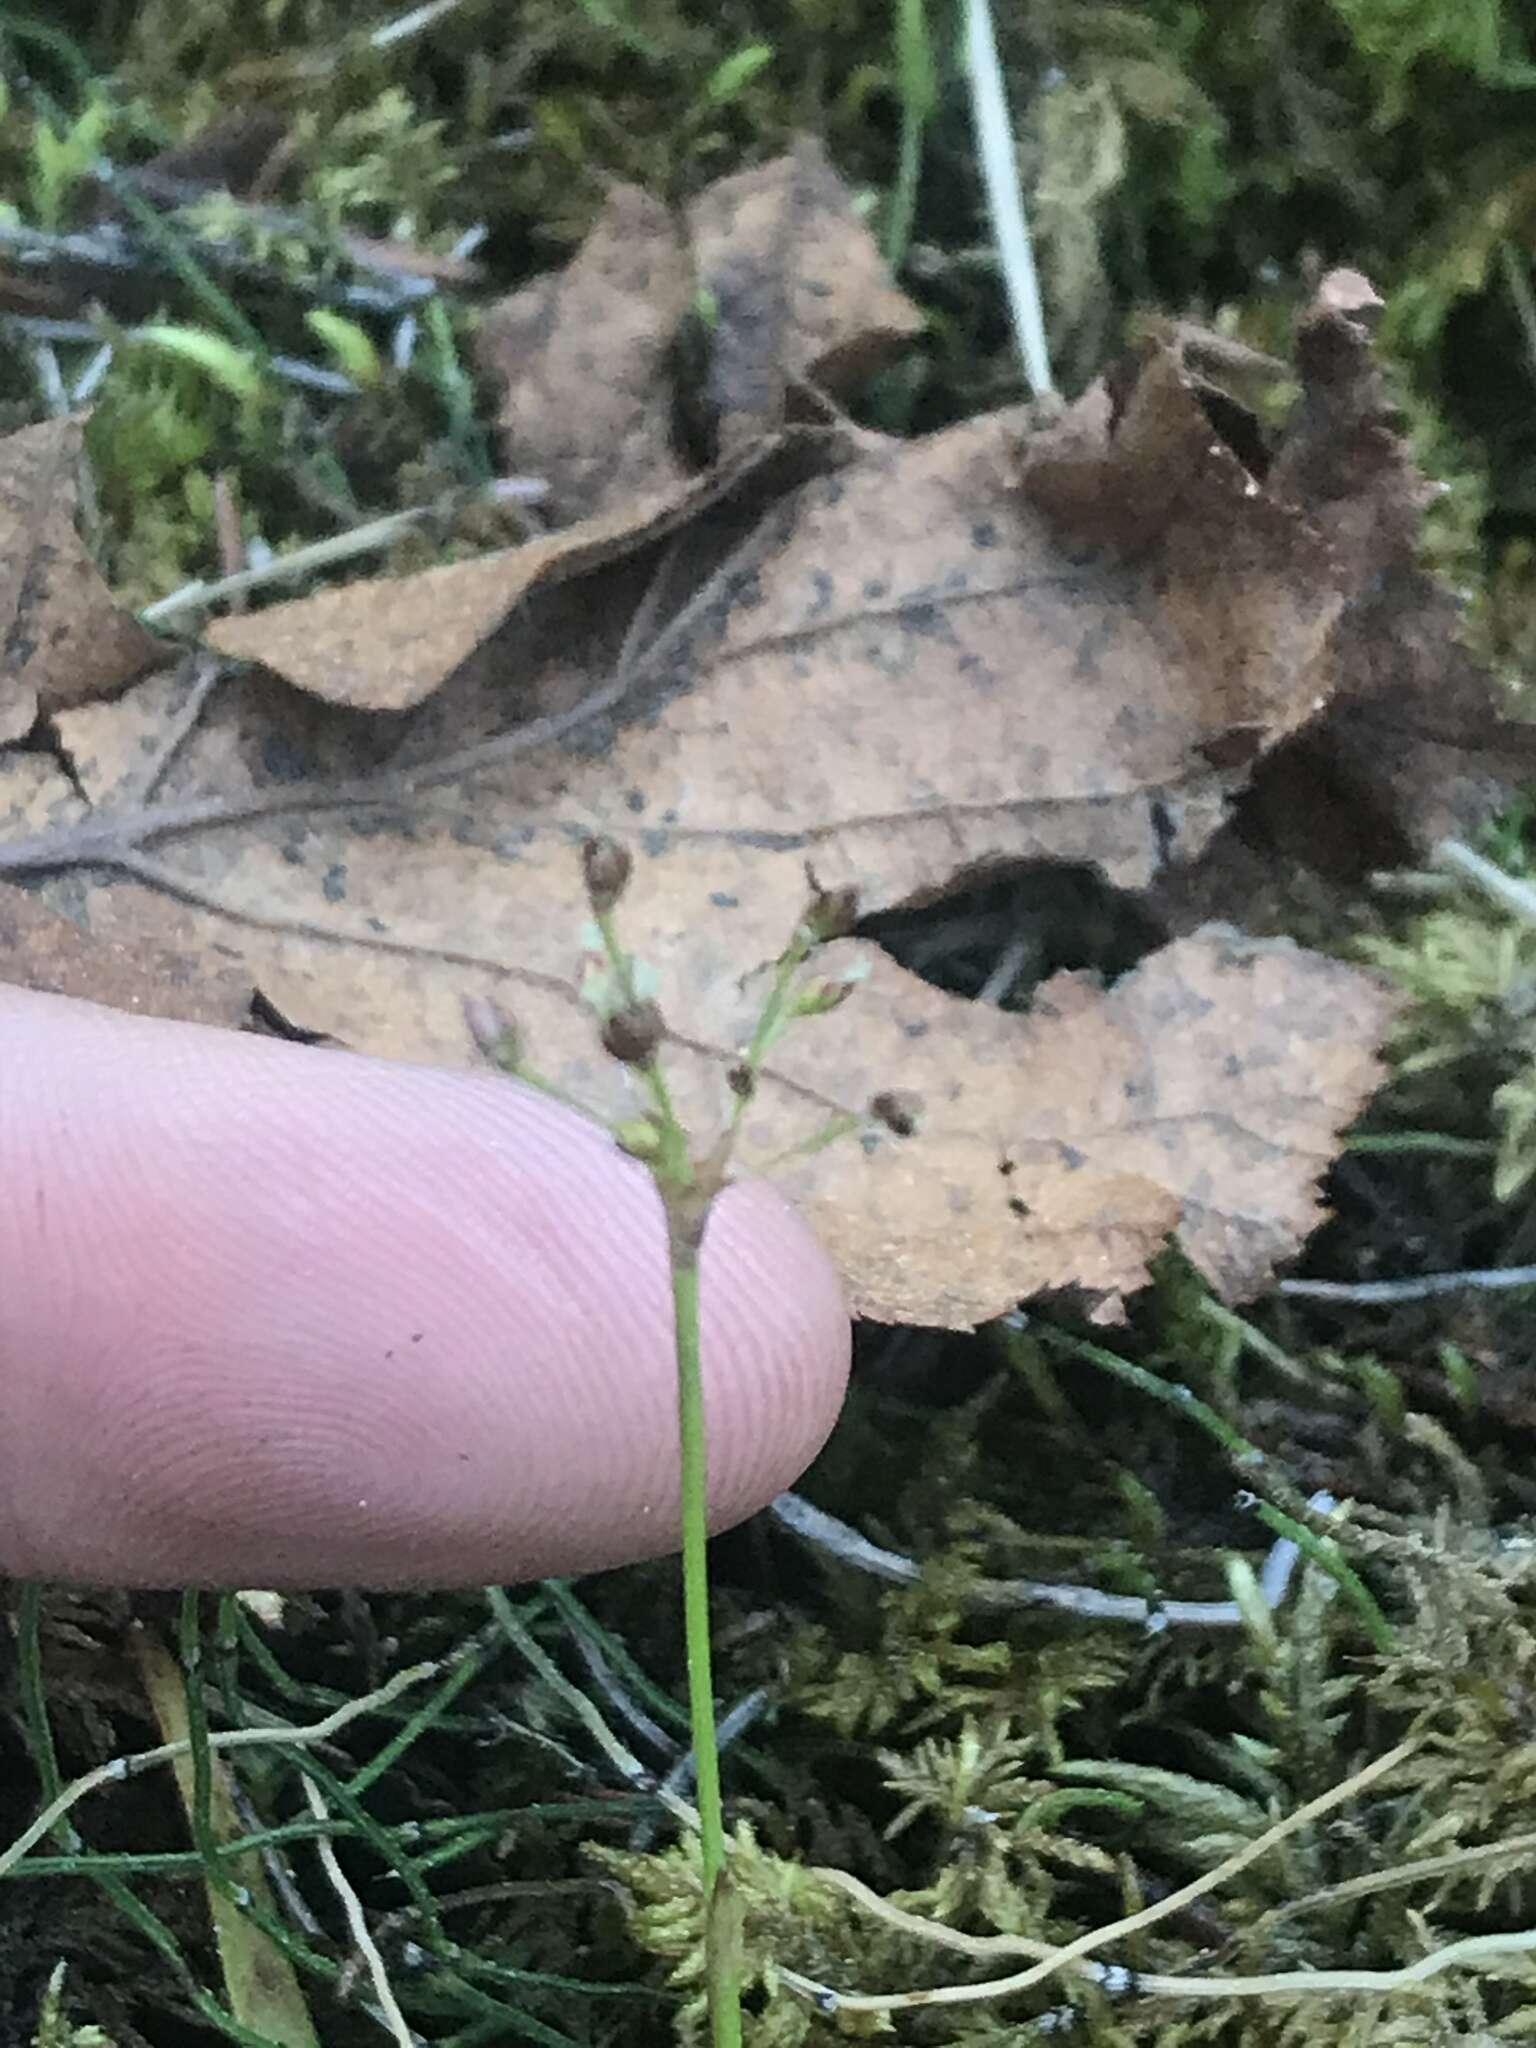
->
0, 989, 848, 1587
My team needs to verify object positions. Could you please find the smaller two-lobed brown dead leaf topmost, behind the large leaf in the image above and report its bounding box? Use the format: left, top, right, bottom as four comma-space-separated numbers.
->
481, 139, 922, 518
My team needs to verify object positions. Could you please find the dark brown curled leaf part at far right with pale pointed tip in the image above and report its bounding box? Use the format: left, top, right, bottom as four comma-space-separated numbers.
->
1159, 270, 1536, 928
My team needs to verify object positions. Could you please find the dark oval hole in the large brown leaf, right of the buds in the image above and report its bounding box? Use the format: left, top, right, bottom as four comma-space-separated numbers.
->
858, 860, 1167, 1010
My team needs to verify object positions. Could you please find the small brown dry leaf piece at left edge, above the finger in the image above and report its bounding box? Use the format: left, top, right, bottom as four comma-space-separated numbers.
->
0, 418, 166, 745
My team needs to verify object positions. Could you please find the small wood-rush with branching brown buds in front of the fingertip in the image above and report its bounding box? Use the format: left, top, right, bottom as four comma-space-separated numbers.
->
465, 838, 913, 2048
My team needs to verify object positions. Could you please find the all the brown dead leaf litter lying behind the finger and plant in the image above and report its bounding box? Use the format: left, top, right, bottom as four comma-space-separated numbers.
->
0, 145, 1522, 1327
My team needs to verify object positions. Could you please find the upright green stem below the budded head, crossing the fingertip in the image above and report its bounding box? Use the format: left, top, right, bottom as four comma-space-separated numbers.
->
672, 1243, 741, 2048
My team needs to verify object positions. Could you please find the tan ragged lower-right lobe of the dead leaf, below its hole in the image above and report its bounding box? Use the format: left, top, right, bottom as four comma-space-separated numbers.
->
776, 928, 1395, 1325
